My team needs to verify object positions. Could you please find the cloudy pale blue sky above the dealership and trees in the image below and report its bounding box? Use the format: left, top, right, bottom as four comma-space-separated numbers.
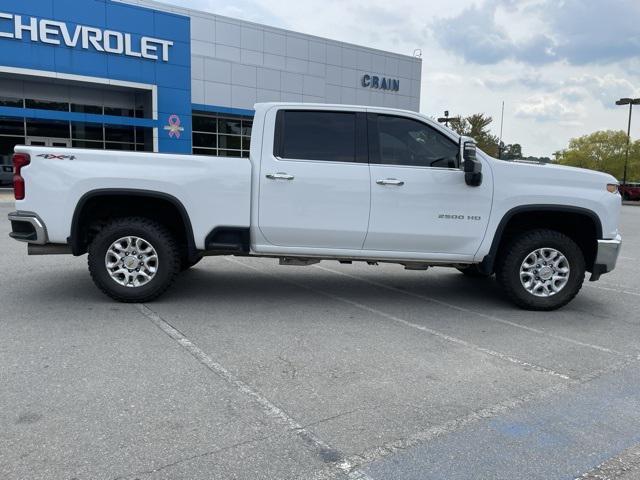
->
162, 0, 640, 156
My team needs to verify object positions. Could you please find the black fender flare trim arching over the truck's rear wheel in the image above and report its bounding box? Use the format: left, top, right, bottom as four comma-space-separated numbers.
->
67, 188, 198, 261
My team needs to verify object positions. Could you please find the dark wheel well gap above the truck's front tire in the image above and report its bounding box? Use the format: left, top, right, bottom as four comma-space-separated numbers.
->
490, 209, 602, 272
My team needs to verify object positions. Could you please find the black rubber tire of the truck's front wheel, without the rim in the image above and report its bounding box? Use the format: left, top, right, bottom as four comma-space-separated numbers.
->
496, 230, 585, 311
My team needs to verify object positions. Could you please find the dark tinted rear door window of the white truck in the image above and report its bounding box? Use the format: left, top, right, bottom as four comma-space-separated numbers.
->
278, 111, 356, 162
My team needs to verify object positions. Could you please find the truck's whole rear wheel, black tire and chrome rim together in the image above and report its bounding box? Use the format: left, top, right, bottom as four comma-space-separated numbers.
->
89, 217, 180, 302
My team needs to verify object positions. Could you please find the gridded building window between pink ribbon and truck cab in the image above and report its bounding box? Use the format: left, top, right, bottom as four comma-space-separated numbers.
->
193, 112, 253, 158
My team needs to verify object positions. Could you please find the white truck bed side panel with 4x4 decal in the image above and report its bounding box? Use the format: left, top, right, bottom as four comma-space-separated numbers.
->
16, 147, 251, 248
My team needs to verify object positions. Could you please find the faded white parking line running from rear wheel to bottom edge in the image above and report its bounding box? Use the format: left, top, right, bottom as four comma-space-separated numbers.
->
137, 304, 372, 480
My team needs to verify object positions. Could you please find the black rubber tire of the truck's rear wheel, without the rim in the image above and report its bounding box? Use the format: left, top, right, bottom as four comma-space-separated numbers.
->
88, 217, 180, 303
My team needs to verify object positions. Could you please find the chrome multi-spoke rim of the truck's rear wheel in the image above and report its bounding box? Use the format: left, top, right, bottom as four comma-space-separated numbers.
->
104, 236, 158, 288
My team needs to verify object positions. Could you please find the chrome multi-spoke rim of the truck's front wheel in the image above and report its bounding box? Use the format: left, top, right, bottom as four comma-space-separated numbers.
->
520, 248, 571, 297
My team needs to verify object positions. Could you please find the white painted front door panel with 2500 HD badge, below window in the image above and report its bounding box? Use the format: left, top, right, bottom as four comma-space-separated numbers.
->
365, 165, 493, 255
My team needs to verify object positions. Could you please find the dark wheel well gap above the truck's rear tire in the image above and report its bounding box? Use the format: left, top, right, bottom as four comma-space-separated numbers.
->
69, 191, 197, 258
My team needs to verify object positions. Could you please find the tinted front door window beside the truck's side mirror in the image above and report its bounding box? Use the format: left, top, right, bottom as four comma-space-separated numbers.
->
371, 115, 459, 168
